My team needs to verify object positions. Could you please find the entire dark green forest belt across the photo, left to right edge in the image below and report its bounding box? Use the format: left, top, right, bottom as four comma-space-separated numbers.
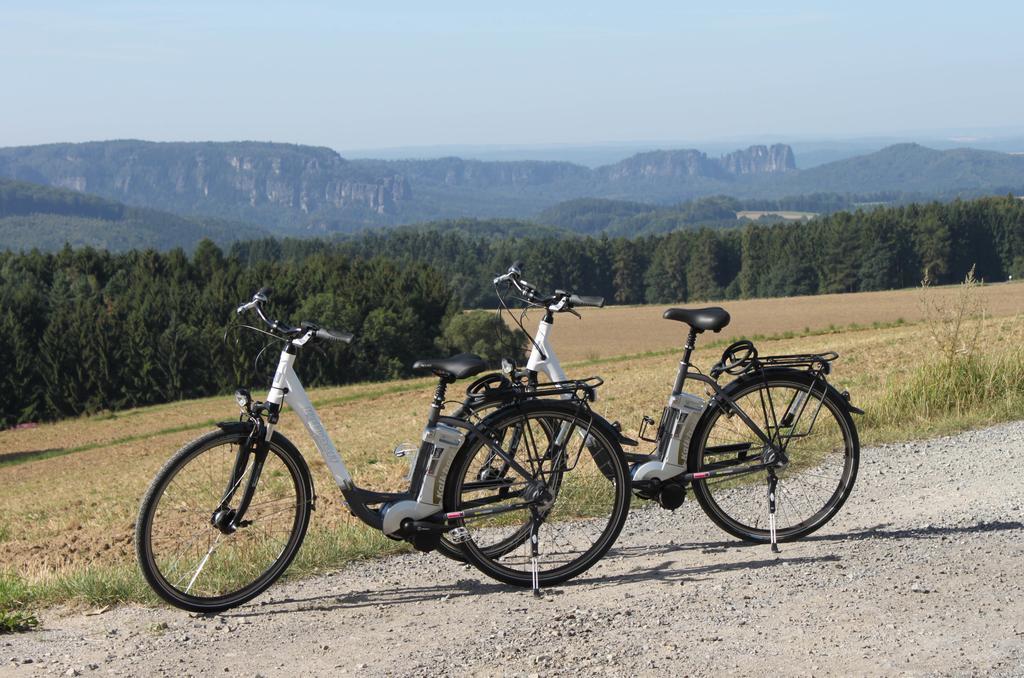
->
0, 196, 1024, 426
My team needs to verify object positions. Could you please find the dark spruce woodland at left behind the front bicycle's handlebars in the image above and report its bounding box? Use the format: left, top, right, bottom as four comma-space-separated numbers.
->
0, 241, 464, 426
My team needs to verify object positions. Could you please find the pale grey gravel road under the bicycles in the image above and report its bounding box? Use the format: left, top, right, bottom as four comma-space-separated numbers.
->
0, 422, 1024, 677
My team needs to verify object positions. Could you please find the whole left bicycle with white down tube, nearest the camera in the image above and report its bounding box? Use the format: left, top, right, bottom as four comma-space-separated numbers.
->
135, 290, 630, 612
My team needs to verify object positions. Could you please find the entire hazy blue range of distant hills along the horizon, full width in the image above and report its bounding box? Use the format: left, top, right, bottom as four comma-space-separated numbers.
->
0, 140, 1024, 237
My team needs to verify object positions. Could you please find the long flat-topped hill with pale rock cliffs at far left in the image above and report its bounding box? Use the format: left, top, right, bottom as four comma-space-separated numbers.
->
0, 141, 411, 220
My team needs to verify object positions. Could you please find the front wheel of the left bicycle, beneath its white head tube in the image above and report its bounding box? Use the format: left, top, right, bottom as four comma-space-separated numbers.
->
135, 430, 312, 612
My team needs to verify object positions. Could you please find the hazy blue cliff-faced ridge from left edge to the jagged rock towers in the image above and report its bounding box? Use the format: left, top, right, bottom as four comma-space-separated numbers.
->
0, 140, 795, 235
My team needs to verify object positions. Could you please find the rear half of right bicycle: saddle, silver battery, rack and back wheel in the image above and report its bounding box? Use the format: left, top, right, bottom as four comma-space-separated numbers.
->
627, 307, 863, 550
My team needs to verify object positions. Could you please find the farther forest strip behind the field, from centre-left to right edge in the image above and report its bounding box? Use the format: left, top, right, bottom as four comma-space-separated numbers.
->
231, 196, 1024, 308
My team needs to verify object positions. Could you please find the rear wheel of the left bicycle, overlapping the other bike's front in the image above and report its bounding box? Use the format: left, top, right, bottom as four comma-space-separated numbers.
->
445, 400, 630, 587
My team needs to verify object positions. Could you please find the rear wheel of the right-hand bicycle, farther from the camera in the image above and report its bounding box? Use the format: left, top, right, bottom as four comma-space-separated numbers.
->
688, 372, 860, 542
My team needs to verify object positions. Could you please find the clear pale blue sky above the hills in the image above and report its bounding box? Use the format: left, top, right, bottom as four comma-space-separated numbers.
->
0, 0, 1024, 150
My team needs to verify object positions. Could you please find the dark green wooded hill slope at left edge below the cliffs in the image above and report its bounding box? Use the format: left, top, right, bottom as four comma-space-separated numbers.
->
0, 179, 267, 251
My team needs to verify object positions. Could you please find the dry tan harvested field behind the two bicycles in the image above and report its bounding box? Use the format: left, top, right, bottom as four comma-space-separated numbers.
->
0, 285, 1024, 608
